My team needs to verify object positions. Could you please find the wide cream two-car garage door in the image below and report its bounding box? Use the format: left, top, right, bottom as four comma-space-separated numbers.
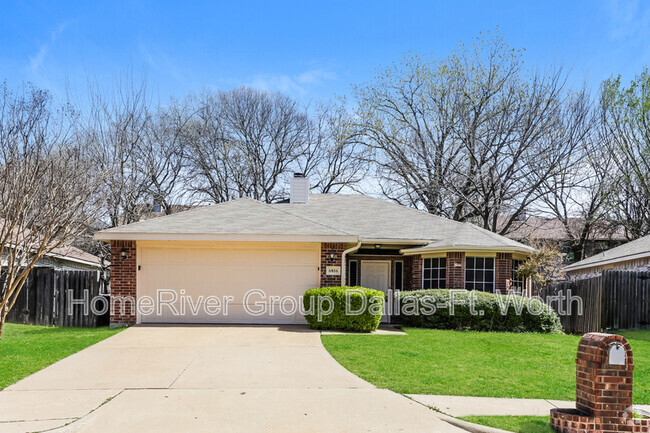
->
138, 242, 320, 323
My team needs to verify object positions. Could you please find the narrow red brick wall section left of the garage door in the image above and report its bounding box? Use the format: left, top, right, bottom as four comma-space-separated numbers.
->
111, 241, 137, 325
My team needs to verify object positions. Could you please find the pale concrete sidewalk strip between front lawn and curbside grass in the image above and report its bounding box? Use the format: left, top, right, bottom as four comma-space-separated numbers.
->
406, 394, 650, 416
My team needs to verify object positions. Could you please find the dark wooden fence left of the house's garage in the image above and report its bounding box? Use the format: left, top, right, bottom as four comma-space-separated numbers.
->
7, 268, 110, 328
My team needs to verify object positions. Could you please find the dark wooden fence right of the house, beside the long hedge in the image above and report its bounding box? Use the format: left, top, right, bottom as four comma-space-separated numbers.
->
544, 271, 650, 334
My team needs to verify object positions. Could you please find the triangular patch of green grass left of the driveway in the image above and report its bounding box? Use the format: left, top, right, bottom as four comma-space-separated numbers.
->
0, 323, 120, 389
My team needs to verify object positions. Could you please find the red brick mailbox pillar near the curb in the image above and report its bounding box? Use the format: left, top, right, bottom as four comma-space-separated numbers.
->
551, 333, 650, 433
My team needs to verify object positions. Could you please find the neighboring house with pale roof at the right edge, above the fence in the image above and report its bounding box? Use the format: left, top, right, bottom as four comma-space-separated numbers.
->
564, 236, 650, 278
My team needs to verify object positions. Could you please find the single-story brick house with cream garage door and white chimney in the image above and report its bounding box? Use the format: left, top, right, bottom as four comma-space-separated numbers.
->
95, 177, 532, 324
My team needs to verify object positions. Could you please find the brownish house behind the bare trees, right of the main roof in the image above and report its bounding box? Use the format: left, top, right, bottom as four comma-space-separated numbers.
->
502, 215, 627, 263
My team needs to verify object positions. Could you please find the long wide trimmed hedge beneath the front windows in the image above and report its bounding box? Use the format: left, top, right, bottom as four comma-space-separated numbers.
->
397, 289, 562, 333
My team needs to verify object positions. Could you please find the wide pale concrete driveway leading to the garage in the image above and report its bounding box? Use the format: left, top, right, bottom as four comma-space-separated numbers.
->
0, 326, 462, 433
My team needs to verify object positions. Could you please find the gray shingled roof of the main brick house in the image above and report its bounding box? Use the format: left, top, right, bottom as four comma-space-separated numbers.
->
98, 194, 532, 251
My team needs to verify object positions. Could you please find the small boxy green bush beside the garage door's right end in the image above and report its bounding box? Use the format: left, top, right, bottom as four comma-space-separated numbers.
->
303, 287, 384, 332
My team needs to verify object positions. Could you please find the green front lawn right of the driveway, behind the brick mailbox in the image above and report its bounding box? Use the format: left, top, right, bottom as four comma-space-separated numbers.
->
322, 328, 650, 404
